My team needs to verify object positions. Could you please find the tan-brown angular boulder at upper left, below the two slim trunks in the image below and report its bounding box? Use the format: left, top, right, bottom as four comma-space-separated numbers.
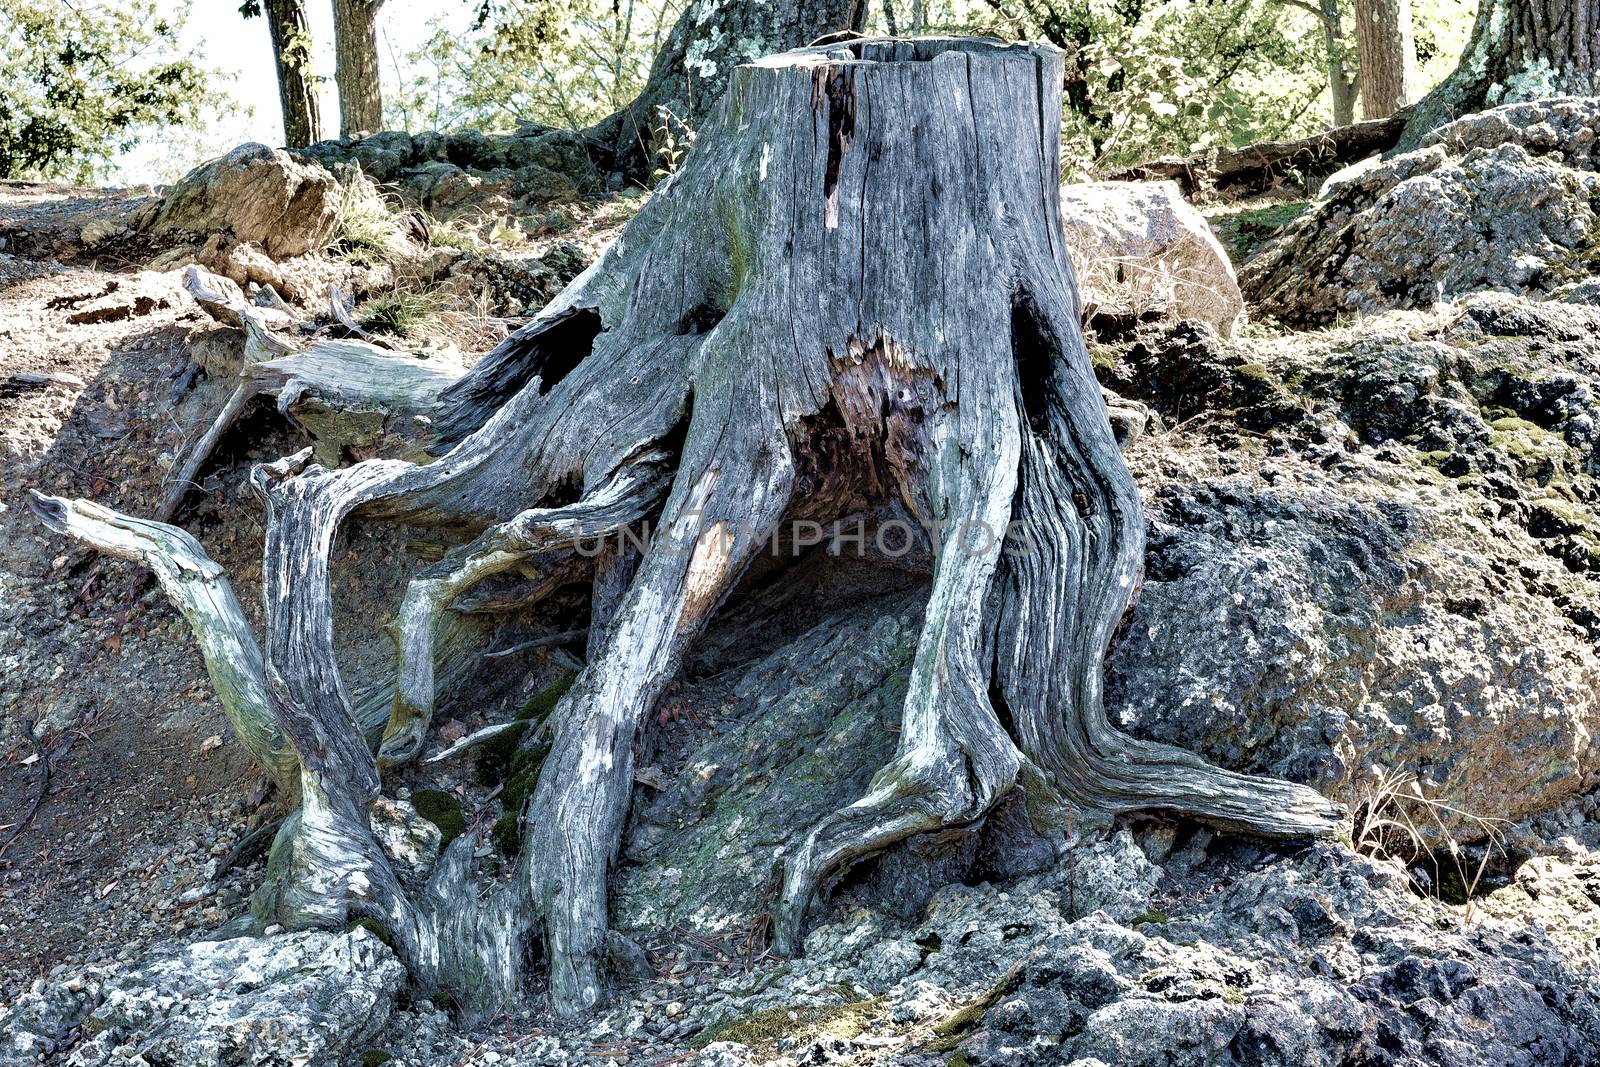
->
136, 144, 341, 259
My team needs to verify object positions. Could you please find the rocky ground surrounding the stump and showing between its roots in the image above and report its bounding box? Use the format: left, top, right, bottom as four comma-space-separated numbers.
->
9, 99, 1600, 1067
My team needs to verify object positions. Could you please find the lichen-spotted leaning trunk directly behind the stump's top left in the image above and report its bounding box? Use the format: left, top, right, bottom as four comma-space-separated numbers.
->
585, 0, 869, 181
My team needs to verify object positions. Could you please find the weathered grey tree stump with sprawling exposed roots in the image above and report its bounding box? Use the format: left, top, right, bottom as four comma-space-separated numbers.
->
38, 38, 1341, 1014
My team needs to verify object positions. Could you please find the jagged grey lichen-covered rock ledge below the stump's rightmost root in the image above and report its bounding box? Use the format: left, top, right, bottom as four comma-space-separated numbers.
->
604, 830, 1600, 1067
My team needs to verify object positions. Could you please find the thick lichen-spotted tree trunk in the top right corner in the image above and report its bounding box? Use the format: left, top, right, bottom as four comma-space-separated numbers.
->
1398, 0, 1600, 150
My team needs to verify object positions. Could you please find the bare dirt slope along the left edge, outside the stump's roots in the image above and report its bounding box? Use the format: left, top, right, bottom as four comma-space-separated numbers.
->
0, 184, 284, 998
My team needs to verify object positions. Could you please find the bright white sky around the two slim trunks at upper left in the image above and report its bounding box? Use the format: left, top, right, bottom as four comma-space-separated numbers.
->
119, 0, 474, 184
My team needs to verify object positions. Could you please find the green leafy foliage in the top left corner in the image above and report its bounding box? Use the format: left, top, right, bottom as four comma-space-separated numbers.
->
0, 0, 218, 182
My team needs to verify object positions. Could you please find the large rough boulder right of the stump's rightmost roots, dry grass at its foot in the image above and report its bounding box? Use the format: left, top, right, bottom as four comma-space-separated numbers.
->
1107, 298, 1600, 830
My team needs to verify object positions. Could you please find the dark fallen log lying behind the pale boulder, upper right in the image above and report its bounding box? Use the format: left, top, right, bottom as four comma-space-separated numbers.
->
1106, 109, 1411, 198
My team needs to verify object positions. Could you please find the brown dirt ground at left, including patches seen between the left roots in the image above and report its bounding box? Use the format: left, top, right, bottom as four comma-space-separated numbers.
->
0, 182, 637, 1003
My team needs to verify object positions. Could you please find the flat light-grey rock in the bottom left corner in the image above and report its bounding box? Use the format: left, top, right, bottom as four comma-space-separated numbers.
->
0, 928, 406, 1067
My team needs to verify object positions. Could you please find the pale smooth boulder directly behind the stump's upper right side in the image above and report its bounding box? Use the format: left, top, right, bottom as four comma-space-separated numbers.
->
1061, 181, 1245, 338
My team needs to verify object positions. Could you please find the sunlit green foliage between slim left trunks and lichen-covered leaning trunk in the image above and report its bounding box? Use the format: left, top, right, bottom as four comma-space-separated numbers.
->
389, 0, 678, 131
